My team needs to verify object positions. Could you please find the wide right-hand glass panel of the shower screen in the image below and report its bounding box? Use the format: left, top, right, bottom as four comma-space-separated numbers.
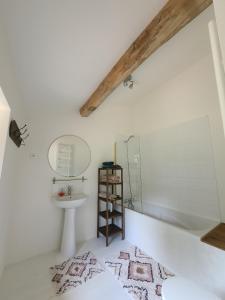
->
141, 117, 220, 222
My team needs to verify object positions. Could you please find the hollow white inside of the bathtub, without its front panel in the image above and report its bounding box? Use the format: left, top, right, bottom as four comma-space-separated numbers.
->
142, 201, 220, 236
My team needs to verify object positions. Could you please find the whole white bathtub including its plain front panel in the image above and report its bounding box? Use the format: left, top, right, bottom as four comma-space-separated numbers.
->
125, 204, 225, 299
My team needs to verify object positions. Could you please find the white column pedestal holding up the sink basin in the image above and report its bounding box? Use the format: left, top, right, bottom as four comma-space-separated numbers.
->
61, 208, 76, 258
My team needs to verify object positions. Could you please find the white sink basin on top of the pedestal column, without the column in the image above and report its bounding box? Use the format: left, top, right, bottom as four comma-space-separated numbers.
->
53, 193, 87, 208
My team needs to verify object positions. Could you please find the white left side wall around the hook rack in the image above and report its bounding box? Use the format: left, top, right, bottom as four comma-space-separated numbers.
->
0, 26, 25, 275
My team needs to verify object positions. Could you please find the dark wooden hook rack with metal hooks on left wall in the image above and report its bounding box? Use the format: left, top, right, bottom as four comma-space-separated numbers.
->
9, 120, 30, 148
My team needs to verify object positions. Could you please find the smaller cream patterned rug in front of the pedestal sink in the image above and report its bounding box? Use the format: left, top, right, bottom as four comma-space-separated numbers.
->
50, 251, 104, 295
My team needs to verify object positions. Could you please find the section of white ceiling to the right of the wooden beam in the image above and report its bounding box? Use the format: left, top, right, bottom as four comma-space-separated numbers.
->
103, 6, 214, 107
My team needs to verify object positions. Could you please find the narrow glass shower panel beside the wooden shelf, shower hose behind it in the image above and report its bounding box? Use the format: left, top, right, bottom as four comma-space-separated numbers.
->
116, 135, 142, 212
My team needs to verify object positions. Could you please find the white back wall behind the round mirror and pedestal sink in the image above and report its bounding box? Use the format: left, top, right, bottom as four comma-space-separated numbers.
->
7, 105, 130, 263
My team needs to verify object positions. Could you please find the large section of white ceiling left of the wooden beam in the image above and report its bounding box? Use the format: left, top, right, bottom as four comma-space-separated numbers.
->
0, 0, 166, 110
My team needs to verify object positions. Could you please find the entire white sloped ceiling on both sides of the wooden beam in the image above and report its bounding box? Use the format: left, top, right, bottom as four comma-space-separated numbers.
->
0, 0, 213, 113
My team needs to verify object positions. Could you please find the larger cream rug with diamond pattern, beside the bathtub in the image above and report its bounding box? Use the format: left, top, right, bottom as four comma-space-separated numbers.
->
105, 246, 174, 300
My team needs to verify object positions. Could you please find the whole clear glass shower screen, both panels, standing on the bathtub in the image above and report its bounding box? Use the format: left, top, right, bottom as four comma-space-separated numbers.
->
116, 116, 221, 232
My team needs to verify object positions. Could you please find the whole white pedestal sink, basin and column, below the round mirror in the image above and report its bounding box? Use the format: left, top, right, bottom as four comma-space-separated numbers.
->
53, 193, 87, 259
